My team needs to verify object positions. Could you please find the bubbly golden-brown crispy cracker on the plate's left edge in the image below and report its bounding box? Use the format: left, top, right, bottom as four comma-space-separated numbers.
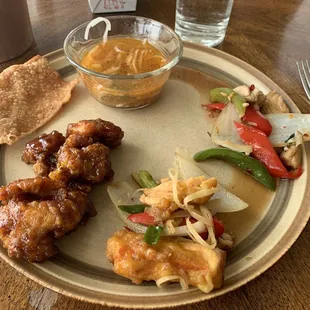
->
0, 55, 78, 144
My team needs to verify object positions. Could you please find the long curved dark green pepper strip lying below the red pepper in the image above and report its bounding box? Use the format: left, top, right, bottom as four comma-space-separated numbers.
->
194, 148, 276, 191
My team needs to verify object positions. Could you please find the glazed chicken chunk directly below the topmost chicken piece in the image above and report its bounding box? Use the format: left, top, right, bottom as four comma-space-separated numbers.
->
49, 141, 114, 184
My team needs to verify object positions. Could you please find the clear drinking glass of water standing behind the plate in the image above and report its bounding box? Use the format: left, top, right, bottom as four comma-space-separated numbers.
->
175, 0, 234, 47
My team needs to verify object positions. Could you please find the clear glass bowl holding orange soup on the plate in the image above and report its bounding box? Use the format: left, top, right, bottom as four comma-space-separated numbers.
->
64, 16, 183, 109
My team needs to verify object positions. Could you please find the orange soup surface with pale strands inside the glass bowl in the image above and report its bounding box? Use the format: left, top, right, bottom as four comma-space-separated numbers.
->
81, 38, 167, 75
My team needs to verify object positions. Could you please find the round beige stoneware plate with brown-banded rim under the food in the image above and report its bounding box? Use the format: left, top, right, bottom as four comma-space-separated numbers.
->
0, 44, 310, 308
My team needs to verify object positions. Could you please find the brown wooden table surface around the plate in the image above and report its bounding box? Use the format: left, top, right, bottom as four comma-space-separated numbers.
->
0, 0, 310, 310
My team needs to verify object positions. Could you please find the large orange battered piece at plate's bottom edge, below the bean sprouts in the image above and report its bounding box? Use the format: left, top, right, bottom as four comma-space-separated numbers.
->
106, 230, 226, 293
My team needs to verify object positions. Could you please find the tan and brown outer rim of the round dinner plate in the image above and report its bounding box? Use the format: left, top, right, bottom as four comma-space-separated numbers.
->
0, 42, 310, 309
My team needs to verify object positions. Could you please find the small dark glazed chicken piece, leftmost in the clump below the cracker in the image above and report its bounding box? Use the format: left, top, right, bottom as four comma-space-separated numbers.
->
22, 130, 66, 176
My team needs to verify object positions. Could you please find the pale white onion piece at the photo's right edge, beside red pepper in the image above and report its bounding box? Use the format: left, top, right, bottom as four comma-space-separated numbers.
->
265, 113, 310, 147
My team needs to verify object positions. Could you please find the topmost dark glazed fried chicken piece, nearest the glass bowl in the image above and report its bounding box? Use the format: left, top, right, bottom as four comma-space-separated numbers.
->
66, 118, 124, 149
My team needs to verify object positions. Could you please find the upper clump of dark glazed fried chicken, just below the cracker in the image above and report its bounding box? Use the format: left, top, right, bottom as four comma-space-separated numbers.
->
22, 119, 124, 184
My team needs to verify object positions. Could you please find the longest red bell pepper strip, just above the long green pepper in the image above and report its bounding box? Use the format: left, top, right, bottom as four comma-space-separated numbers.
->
234, 122, 302, 179
